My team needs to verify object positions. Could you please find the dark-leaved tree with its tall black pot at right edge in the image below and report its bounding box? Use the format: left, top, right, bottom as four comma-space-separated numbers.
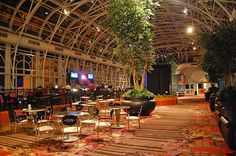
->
199, 21, 236, 148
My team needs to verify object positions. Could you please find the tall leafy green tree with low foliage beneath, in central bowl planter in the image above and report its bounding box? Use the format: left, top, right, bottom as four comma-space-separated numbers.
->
103, 0, 157, 115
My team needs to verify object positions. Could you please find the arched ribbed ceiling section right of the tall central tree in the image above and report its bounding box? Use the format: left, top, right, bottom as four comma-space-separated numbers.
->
154, 0, 236, 63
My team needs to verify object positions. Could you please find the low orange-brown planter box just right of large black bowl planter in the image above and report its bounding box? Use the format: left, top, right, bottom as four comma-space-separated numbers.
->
155, 96, 177, 106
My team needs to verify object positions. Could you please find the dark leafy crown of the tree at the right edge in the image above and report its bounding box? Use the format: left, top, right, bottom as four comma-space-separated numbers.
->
198, 21, 236, 82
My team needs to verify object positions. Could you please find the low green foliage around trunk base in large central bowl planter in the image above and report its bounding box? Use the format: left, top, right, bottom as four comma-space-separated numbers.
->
123, 89, 155, 98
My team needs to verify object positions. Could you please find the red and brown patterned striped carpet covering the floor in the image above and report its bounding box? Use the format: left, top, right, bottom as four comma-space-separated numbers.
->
0, 101, 236, 156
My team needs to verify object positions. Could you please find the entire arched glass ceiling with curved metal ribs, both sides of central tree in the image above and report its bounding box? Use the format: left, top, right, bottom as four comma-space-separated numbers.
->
0, 0, 236, 63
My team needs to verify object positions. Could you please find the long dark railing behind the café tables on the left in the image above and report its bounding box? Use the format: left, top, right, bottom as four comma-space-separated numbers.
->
0, 88, 123, 111
